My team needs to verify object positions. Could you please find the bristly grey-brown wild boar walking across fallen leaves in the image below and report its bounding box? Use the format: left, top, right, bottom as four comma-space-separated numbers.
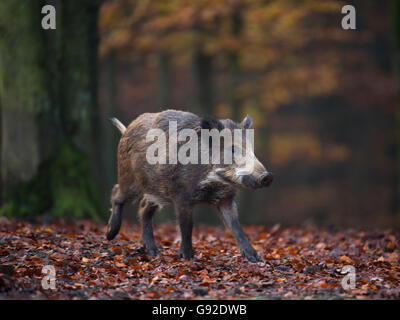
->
106, 110, 273, 262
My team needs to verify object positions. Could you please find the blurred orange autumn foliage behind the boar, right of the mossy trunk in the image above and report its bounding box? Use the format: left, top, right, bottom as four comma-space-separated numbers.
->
99, 0, 400, 228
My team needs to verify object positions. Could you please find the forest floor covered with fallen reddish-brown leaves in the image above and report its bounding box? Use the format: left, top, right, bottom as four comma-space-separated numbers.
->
0, 217, 400, 299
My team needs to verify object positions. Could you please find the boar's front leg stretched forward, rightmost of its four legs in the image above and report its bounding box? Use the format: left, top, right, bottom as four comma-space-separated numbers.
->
218, 199, 261, 262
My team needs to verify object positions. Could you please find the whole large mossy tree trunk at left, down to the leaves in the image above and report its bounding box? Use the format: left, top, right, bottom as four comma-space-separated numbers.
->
0, 0, 102, 218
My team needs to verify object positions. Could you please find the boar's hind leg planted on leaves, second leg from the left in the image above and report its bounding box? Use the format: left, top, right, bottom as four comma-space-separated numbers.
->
139, 198, 158, 257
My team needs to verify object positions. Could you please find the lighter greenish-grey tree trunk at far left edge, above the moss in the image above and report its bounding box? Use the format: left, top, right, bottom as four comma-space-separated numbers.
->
0, 0, 51, 192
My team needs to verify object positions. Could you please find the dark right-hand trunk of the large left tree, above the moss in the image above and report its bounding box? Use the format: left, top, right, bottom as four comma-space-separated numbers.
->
57, 0, 99, 159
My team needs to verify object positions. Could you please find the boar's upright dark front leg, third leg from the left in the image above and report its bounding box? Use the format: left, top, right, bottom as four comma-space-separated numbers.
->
175, 205, 193, 260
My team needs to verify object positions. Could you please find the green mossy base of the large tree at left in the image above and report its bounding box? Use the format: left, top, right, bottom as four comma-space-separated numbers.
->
0, 142, 104, 220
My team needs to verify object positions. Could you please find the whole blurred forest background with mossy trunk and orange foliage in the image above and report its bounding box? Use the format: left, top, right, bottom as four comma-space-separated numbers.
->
0, 0, 400, 228
